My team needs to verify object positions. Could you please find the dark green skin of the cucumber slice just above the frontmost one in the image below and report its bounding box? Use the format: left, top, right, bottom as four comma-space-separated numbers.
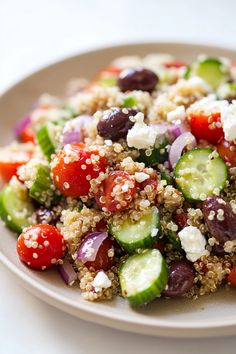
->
108, 212, 162, 254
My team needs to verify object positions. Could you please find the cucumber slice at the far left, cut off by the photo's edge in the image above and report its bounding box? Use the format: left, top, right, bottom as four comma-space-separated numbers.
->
0, 182, 34, 233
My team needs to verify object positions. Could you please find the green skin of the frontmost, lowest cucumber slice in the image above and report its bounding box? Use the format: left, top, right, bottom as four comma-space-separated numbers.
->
119, 252, 169, 307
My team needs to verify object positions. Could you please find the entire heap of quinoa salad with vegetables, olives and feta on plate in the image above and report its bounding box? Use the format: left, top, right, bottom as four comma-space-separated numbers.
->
0, 54, 236, 306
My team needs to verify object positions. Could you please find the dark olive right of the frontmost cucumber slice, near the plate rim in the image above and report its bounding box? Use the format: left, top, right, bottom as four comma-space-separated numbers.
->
162, 260, 194, 297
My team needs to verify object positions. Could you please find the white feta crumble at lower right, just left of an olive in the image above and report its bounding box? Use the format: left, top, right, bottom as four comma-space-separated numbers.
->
178, 226, 208, 262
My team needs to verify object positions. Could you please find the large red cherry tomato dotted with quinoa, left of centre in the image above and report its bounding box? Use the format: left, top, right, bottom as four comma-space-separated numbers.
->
52, 144, 107, 198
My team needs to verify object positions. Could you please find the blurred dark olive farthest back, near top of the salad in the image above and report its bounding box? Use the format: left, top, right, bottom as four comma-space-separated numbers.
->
118, 68, 158, 92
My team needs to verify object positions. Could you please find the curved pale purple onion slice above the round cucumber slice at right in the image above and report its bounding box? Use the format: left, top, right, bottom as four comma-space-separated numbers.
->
169, 132, 197, 167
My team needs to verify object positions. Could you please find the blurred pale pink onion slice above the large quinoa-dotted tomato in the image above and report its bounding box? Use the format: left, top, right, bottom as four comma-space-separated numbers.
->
62, 115, 93, 146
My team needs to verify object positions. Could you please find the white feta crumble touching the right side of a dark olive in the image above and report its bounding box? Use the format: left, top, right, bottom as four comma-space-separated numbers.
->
127, 112, 157, 149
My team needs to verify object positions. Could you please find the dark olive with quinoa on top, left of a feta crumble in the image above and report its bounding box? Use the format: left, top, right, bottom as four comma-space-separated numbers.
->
97, 108, 138, 141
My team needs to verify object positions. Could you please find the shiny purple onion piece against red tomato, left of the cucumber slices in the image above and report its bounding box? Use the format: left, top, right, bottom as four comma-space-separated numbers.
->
76, 232, 109, 263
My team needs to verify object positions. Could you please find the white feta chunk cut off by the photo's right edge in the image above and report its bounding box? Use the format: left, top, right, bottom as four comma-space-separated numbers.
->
221, 100, 236, 141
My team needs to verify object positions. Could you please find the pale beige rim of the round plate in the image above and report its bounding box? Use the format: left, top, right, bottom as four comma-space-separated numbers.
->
0, 40, 236, 337
